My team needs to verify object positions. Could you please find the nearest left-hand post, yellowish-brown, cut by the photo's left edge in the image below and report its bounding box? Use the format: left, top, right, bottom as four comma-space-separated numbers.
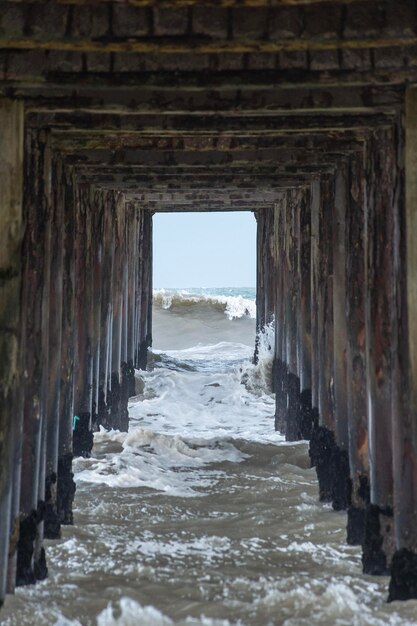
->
0, 100, 24, 606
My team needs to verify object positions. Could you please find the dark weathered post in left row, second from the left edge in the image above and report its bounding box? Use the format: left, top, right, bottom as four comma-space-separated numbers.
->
16, 131, 51, 585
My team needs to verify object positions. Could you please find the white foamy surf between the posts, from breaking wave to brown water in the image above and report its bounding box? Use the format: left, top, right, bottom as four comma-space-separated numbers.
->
76, 290, 281, 496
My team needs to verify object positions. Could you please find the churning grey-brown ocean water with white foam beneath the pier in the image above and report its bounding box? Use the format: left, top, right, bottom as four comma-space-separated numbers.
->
0, 289, 417, 626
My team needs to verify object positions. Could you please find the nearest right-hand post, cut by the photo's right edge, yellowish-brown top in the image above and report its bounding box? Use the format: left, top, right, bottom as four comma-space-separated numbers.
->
389, 86, 417, 600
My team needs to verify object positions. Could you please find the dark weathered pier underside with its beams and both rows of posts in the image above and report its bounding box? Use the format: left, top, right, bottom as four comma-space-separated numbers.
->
0, 0, 417, 602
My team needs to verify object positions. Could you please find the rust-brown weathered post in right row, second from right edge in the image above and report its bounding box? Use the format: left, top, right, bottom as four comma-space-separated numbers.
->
362, 129, 397, 575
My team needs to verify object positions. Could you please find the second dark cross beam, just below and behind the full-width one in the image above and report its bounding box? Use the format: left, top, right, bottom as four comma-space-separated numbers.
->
25, 109, 396, 132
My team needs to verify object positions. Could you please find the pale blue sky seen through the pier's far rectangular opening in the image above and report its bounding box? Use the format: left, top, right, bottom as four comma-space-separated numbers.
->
153, 211, 256, 288
